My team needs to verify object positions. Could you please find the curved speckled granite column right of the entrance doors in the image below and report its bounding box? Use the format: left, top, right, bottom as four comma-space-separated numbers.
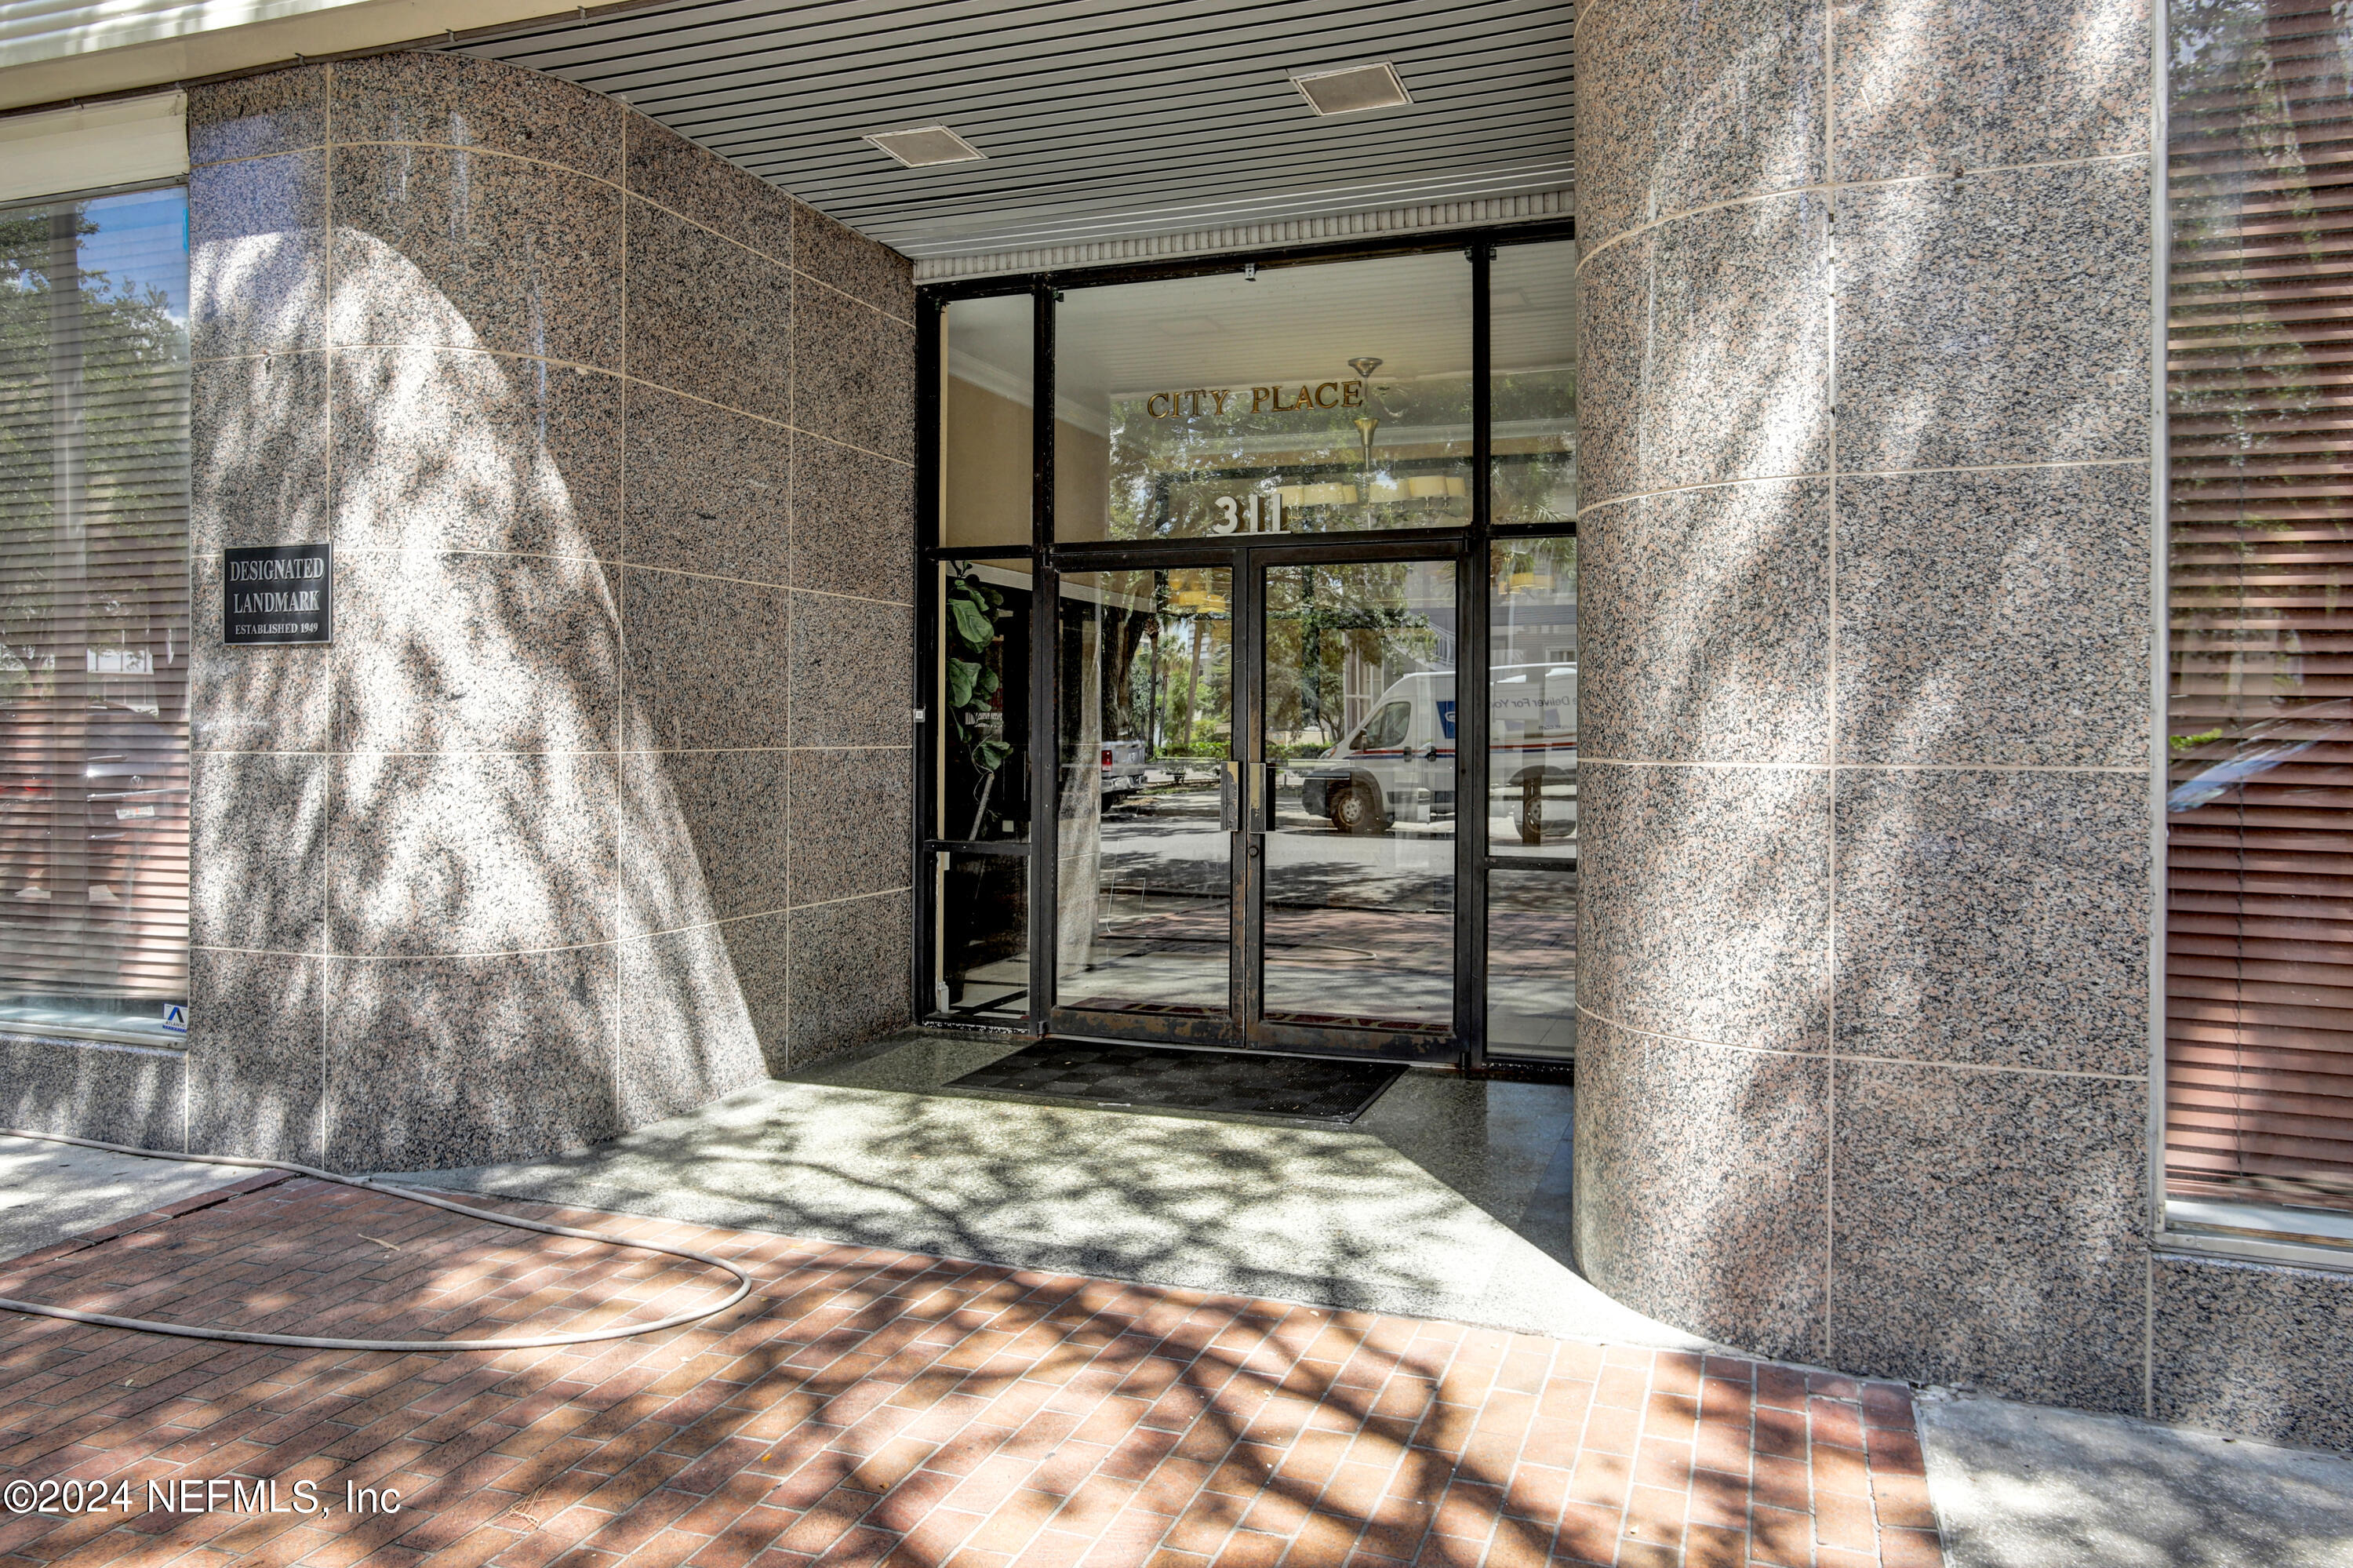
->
1577, 0, 2151, 1408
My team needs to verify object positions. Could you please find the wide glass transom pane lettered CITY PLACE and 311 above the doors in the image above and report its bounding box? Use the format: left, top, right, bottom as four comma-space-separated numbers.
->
1054, 249, 1471, 544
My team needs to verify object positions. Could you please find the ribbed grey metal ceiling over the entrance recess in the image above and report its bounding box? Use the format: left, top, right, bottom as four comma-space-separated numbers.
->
459, 0, 1574, 256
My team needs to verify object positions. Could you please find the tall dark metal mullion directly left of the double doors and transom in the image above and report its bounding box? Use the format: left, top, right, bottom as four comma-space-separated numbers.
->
1028, 285, 1061, 1034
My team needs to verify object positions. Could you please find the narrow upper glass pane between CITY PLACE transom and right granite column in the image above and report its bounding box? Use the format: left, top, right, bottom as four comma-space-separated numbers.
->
1487, 240, 1577, 527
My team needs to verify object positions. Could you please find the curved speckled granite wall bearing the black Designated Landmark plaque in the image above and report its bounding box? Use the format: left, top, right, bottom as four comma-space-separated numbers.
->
117, 54, 915, 1168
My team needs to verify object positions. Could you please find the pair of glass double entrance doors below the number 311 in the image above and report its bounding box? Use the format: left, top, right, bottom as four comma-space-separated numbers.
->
1052, 539, 1461, 1057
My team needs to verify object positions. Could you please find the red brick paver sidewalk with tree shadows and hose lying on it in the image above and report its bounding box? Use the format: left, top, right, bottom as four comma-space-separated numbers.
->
0, 1177, 1941, 1568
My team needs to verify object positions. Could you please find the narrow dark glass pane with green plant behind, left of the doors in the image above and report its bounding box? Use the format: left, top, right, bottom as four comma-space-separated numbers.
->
932, 560, 1033, 843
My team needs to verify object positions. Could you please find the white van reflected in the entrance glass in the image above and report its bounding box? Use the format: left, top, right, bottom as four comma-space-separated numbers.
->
1292, 664, 1577, 843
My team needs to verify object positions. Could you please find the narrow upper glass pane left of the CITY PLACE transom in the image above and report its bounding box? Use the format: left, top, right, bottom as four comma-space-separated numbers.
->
939, 294, 1038, 551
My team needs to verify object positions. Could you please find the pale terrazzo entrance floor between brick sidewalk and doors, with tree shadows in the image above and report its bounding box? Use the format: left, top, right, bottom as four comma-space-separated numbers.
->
405, 1034, 1704, 1349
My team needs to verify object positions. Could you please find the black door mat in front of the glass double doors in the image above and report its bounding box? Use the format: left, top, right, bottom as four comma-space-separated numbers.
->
944, 1043, 1405, 1126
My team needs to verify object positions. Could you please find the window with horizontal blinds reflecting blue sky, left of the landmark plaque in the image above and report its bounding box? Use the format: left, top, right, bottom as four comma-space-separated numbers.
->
0, 188, 188, 1039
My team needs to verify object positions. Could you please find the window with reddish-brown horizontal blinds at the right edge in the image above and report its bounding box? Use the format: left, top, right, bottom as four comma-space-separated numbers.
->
2165, 0, 2353, 1210
